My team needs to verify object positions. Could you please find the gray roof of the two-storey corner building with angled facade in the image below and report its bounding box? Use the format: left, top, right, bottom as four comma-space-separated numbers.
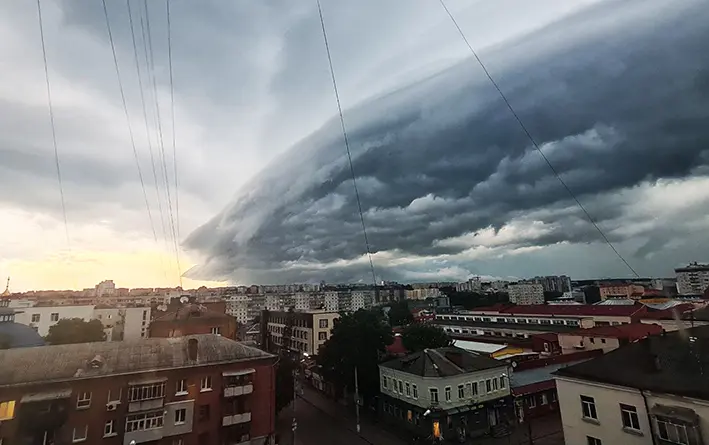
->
380, 346, 507, 377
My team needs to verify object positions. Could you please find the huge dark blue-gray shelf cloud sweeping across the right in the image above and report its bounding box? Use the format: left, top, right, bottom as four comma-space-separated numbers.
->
185, 1, 709, 282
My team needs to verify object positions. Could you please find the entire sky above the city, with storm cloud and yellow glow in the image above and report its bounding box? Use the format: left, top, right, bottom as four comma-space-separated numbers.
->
0, 0, 709, 290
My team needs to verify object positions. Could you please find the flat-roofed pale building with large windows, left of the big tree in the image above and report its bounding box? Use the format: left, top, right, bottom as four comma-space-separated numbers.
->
261, 311, 340, 355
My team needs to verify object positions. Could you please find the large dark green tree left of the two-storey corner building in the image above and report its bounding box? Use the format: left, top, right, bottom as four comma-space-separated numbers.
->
317, 309, 393, 402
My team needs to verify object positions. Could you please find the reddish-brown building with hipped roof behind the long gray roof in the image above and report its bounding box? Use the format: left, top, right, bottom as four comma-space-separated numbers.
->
148, 304, 237, 340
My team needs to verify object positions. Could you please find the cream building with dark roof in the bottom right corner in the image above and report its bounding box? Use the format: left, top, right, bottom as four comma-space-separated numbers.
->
555, 326, 709, 445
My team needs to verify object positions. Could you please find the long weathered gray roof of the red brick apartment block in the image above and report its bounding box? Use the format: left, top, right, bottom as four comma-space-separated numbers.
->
0, 334, 275, 387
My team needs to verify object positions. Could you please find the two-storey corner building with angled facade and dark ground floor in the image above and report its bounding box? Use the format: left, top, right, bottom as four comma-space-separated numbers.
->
379, 346, 514, 440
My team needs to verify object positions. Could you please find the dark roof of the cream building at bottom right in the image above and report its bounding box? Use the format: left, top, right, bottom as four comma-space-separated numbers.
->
556, 326, 709, 400
